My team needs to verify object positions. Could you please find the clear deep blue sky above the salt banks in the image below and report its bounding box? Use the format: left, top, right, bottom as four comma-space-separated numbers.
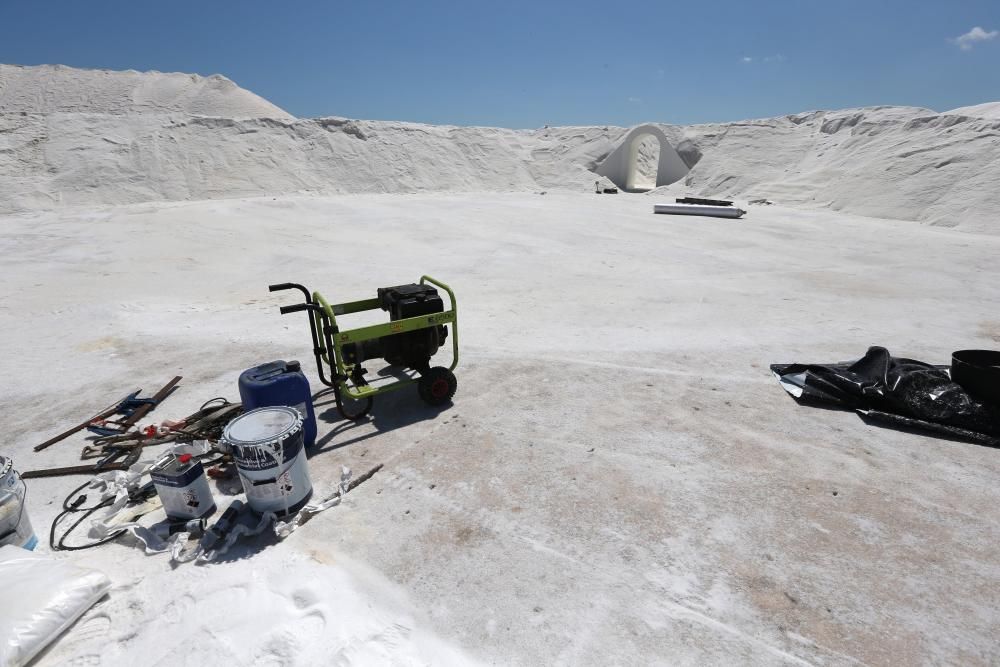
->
0, 0, 1000, 127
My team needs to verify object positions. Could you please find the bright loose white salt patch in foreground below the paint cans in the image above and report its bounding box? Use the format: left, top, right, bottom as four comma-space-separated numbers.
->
40, 538, 476, 666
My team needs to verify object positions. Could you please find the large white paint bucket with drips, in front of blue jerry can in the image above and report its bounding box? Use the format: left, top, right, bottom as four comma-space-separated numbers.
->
222, 406, 312, 516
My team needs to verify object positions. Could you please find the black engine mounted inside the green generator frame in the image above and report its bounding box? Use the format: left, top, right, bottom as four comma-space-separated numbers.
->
342, 283, 448, 372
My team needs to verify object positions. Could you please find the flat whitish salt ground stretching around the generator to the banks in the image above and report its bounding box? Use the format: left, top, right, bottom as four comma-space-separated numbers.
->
0, 193, 1000, 665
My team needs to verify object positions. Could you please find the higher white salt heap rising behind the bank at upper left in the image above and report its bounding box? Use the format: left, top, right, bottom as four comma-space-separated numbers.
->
0, 65, 294, 120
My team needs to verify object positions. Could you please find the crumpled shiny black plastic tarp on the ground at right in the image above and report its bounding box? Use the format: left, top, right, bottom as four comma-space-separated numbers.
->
771, 347, 1000, 447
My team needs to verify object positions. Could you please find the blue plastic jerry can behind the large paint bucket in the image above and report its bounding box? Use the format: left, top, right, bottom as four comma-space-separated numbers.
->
239, 361, 316, 447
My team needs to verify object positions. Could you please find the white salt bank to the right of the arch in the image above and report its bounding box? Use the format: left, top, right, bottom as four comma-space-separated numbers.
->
652, 107, 1000, 233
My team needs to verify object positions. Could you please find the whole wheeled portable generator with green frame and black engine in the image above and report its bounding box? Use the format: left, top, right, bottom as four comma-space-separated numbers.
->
268, 276, 458, 419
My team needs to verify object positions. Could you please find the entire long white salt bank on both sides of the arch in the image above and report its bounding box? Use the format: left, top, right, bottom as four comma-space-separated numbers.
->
0, 65, 1000, 233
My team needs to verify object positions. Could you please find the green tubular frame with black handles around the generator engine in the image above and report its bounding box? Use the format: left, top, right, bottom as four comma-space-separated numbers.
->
268, 275, 458, 419
